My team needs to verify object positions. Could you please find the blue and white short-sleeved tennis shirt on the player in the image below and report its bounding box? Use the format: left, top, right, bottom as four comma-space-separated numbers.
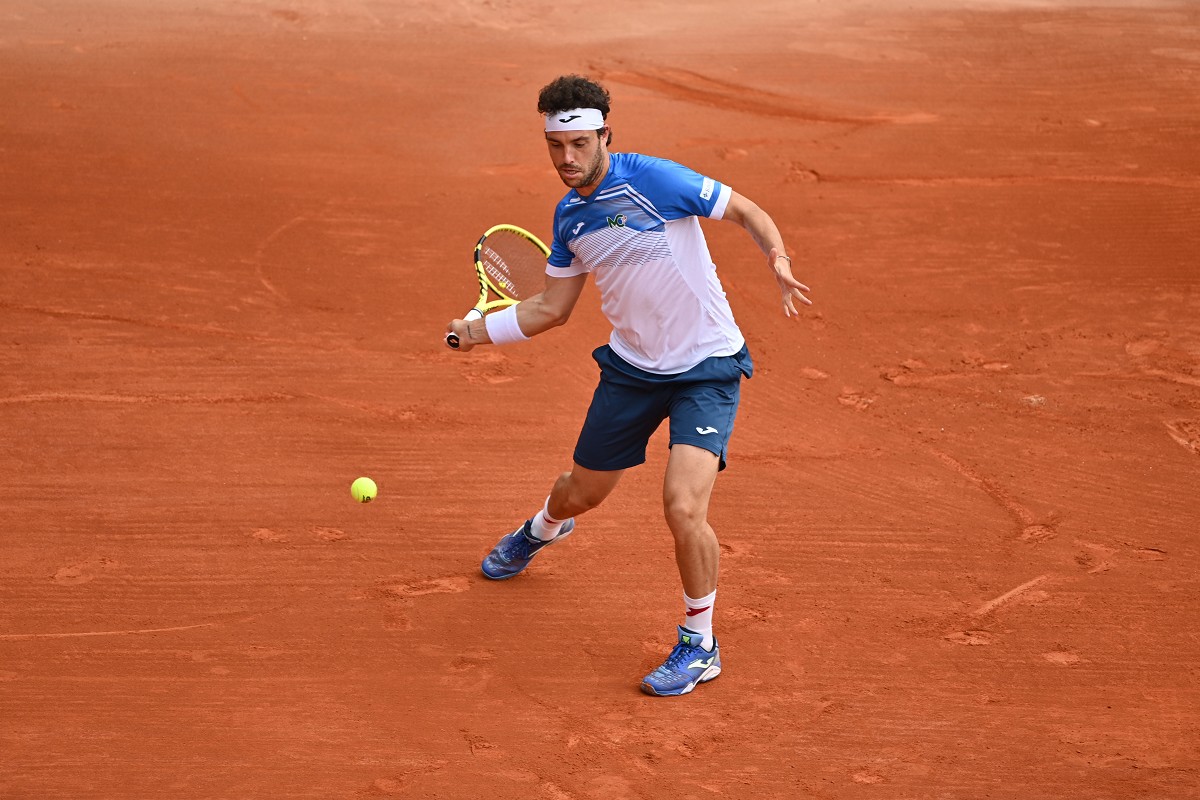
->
546, 152, 745, 374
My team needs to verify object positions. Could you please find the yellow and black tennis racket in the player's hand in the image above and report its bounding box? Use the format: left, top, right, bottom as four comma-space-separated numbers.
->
446, 225, 550, 350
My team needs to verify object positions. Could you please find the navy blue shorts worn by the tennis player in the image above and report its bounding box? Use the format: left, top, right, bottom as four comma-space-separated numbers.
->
575, 344, 754, 471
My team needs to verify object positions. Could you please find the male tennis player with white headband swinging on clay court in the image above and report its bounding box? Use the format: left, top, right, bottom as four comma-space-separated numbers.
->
446, 76, 810, 696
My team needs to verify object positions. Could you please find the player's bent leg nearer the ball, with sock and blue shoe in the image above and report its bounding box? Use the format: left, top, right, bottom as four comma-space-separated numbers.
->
481, 464, 624, 581
